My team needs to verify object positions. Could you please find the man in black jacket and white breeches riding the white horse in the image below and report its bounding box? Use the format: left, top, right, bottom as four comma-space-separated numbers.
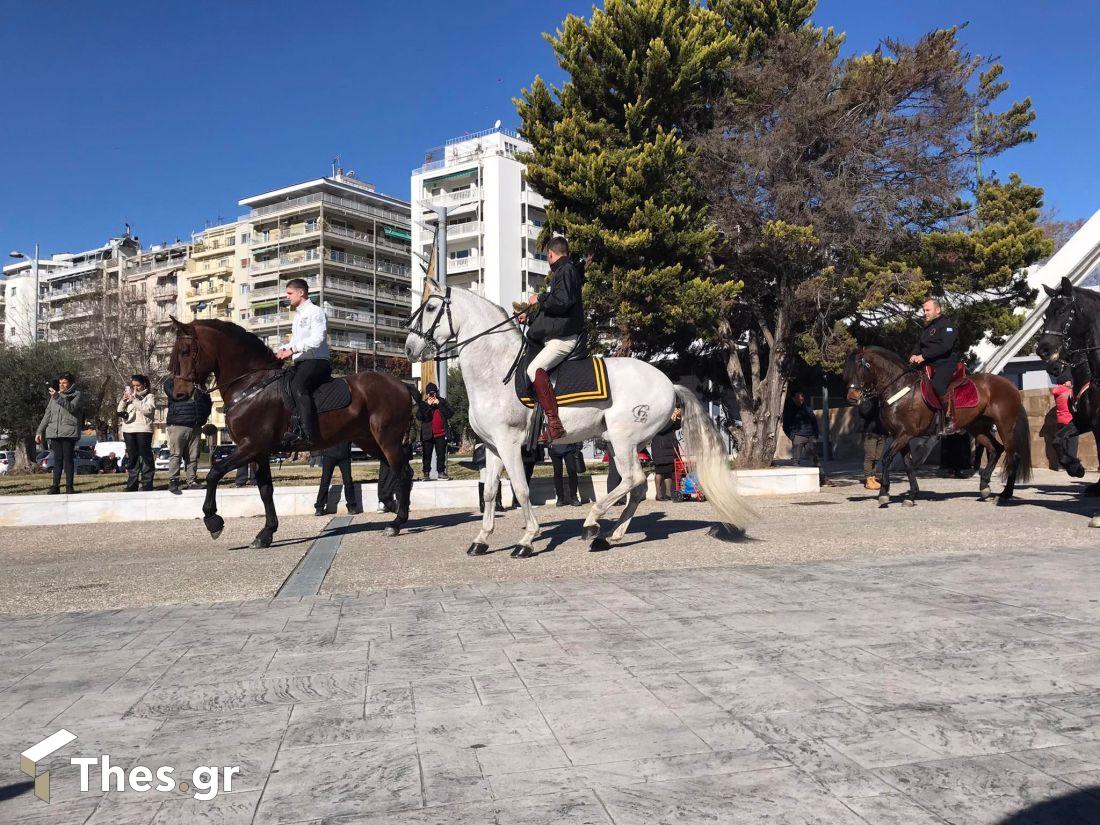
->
514, 237, 584, 440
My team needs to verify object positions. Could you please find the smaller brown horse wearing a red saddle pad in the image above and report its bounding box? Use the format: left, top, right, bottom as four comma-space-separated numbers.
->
844, 347, 1031, 507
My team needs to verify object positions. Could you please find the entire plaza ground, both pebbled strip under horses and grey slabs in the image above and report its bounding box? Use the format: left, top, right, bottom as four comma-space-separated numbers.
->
0, 475, 1100, 825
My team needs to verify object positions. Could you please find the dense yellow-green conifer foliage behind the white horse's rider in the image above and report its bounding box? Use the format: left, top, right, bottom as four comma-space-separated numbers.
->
516, 0, 814, 354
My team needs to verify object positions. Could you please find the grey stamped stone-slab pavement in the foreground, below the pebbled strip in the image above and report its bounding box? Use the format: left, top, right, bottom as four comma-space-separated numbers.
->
0, 545, 1100, 825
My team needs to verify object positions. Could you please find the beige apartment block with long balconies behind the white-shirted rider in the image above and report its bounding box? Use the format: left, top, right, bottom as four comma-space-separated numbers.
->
238, 169, 410, 370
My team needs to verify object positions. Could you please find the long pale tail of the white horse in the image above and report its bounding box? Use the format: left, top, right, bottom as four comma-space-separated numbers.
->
673, 384, 756, 537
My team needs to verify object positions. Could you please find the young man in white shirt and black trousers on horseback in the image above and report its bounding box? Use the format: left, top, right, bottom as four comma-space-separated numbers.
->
275, 278, 332, 450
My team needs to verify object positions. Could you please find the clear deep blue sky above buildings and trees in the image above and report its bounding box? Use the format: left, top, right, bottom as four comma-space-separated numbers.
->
0, 0, 1100, 263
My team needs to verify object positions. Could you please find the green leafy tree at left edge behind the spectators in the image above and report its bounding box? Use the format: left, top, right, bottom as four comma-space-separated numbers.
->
0, 344, 81, 466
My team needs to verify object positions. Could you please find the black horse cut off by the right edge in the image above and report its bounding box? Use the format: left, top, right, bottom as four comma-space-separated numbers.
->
1035, 278, 1100, 501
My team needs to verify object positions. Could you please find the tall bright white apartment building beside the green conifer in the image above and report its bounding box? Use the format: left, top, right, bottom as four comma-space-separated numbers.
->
411, 127, 550, 307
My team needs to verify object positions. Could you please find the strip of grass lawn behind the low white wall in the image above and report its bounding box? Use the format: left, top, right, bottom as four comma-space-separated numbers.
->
0, 457, 606, 496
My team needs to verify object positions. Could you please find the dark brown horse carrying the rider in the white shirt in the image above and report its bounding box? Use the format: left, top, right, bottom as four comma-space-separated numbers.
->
169, 318, 417, 548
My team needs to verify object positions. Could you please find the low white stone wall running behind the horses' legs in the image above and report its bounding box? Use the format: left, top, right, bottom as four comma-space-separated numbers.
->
0, 466, 818, 527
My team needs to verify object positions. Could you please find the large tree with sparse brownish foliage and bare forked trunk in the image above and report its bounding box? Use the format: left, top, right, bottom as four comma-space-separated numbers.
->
693, 28, 1049, 464
